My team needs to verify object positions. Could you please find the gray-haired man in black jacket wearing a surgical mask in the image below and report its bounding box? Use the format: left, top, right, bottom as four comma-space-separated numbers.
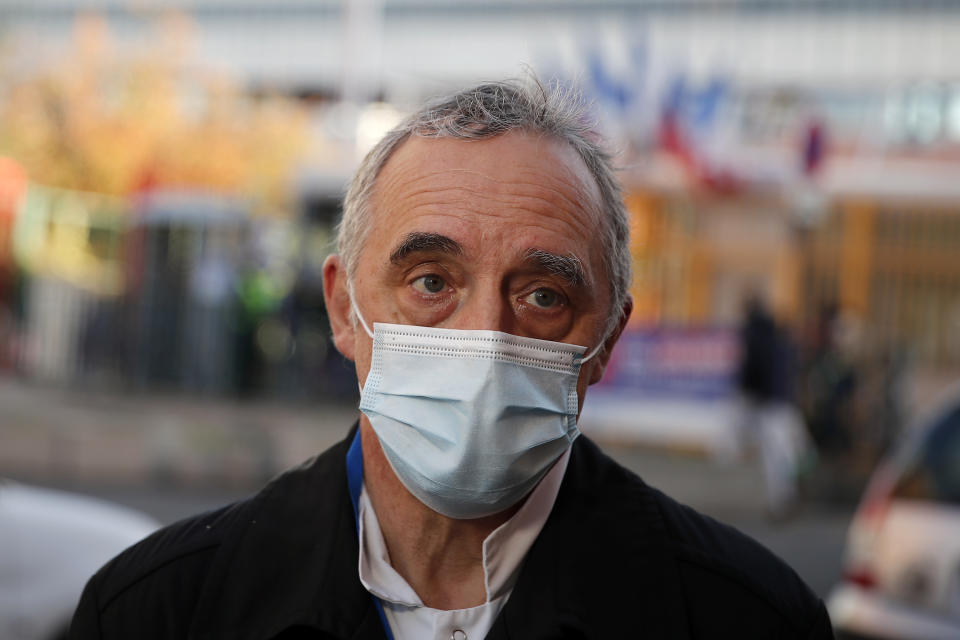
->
72, 83, 831, 640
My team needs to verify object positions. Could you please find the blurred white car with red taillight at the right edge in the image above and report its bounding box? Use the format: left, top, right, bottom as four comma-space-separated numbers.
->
828, 392, 960, 640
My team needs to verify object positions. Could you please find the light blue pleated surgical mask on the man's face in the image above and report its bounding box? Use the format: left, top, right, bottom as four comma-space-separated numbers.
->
351, 296, 600, 518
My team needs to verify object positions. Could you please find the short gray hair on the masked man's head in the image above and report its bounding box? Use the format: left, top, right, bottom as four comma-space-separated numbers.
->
337, 79, 631, 331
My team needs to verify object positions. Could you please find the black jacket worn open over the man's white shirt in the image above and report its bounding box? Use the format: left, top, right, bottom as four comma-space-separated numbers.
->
71, 432, 832, 640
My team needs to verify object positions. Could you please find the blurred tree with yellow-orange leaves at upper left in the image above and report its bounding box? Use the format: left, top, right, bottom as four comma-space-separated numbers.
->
0, 15, 308, 213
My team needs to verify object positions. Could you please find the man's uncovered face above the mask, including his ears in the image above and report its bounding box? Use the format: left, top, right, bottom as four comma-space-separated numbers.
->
325, 132, 619, 406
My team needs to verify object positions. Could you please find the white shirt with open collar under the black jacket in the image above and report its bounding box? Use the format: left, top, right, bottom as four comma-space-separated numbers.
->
358, 449, 570, 640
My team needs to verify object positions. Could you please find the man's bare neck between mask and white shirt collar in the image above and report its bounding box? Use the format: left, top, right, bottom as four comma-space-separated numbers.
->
360, 416, 519, 610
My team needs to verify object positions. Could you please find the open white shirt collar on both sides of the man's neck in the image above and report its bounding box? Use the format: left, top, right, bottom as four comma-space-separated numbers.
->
358, 449, 570, 607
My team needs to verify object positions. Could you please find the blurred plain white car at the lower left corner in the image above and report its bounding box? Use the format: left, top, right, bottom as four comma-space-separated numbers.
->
0, 479, 159, 640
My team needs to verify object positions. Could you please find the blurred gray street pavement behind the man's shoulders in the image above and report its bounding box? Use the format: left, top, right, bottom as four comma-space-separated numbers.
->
0, 379, 852, 596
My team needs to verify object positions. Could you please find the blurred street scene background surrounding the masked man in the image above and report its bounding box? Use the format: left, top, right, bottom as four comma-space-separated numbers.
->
0, 0, 960, 637
